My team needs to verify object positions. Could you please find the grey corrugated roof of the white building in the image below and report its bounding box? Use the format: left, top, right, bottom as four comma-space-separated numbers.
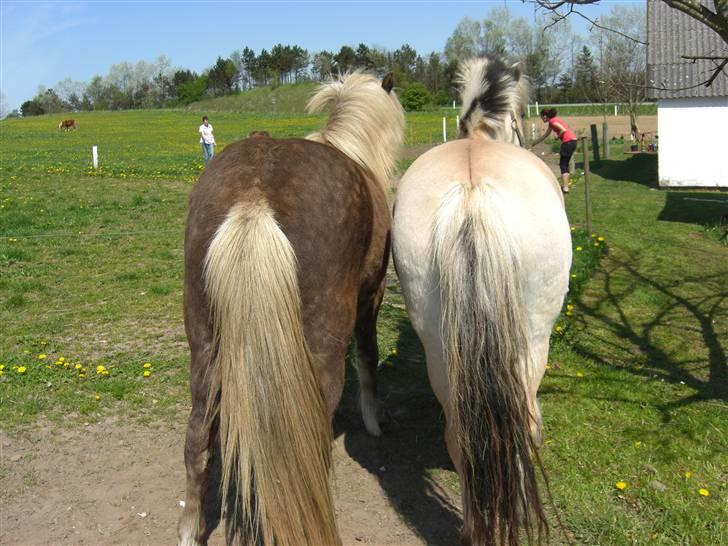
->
647, 0, 728, 99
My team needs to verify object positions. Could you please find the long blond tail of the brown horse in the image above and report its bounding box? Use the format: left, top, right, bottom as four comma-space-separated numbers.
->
204, 201, 339, 546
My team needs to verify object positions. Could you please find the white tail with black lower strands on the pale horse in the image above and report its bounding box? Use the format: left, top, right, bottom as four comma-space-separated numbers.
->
433, 180, 547, 545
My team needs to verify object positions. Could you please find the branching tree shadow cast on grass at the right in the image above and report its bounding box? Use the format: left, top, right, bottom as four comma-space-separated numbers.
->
574, 251, 728, 421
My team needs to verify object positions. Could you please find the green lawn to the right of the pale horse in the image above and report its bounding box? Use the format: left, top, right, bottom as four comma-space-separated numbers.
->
540, 151, 728, 544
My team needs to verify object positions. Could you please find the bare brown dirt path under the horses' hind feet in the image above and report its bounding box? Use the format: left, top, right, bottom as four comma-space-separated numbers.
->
0, 398, 459, 545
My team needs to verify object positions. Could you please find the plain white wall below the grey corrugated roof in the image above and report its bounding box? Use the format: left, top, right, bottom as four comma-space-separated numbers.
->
657, 97, 728, 188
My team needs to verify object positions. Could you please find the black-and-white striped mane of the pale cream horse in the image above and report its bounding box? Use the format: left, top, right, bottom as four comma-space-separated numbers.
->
457, 57, 530, 140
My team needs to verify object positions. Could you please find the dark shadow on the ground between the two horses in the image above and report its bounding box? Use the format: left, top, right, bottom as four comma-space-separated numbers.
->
334, 304, 462, 545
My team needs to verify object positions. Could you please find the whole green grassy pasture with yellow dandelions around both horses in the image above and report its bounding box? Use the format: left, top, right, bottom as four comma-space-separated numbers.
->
0, 111, 728, 545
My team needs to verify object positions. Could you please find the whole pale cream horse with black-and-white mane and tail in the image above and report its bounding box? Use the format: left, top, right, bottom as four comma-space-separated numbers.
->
392, 59, 571, 545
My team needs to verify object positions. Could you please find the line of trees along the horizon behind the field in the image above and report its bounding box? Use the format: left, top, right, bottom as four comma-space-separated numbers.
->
17, 6, 645, 116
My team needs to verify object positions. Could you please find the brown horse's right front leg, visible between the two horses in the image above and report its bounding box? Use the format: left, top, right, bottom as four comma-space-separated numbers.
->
355, 278, 384, 437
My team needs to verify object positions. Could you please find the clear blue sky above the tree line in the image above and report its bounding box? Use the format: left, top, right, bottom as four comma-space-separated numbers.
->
0, 0, 633, 109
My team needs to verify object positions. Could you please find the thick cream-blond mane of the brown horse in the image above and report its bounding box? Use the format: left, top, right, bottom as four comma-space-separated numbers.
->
306, 70, 404, 194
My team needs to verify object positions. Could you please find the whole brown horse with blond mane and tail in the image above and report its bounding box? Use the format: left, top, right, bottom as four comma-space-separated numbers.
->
179, 72, 404, 546
